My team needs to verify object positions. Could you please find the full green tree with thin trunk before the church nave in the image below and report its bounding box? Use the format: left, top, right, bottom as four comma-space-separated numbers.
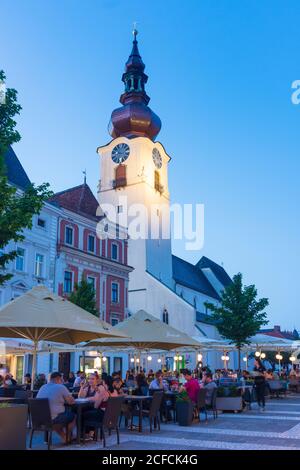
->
205, 273, 269, 370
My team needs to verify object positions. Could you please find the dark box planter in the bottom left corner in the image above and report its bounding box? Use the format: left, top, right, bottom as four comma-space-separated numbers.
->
0, 405, 28, 450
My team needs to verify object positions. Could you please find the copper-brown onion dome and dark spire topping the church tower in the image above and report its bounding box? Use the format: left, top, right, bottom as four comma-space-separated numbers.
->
109, 29, 161, 140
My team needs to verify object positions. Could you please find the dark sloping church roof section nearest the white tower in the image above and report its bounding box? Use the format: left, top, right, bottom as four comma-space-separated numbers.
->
172, 255, 219, 299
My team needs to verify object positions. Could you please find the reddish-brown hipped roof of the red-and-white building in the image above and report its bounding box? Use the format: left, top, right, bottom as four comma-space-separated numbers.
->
48, 183, 99, 220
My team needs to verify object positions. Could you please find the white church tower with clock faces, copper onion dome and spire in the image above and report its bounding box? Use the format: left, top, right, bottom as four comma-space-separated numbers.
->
97, 30, 173, 311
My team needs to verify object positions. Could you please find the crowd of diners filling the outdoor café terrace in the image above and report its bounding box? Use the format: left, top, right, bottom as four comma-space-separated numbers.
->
0, 358, 300, 440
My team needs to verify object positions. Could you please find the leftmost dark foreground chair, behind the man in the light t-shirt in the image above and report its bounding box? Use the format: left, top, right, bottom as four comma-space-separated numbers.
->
28, 398, 68, 450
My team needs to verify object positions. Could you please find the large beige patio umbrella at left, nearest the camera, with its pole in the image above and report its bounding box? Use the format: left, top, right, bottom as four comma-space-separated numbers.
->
0, 285, 125, 385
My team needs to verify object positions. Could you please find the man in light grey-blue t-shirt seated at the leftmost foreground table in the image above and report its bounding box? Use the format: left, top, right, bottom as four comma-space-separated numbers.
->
37, 372, 76, 442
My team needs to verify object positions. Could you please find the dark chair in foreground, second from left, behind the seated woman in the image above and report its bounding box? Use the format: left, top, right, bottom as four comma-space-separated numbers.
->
84, 396, 124, 447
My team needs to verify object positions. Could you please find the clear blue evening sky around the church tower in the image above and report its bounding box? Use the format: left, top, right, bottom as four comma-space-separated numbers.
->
0, 0, 300, 329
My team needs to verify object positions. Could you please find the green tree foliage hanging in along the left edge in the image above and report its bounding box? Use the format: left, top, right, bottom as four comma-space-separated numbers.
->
0, 71, 52, 286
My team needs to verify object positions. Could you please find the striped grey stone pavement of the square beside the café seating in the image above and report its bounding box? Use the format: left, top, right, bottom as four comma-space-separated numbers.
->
27, 395, 300, 450
